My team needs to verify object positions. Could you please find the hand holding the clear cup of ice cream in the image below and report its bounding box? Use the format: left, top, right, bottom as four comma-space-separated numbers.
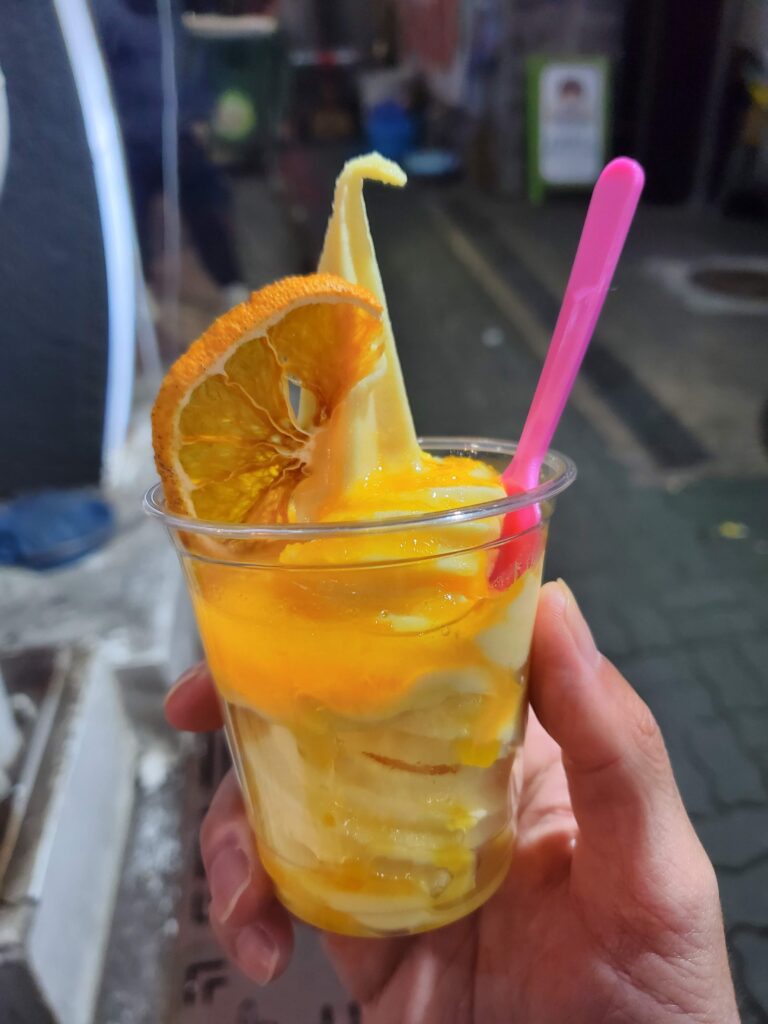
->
166, 583, 738, 1024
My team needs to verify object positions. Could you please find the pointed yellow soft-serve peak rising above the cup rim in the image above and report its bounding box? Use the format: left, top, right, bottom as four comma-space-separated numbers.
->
293, 154, 512, 521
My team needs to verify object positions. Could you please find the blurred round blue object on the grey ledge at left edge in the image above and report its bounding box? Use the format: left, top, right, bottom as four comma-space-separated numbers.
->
0, 490, 115, 569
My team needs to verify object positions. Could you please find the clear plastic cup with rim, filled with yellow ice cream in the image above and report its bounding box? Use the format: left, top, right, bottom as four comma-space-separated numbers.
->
144, 438, 575, 936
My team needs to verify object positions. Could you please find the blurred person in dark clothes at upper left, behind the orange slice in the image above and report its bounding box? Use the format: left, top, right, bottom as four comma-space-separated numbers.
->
91, 0, 250, 308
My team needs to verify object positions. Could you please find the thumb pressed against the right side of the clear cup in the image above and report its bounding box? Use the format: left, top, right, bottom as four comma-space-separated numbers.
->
530, 581, 692, 857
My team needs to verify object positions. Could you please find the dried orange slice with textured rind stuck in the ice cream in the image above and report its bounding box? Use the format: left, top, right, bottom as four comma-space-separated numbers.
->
152, 273, 382, 522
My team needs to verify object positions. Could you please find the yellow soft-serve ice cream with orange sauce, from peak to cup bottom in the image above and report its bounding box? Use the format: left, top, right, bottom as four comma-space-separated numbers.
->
151, 156, 545, 935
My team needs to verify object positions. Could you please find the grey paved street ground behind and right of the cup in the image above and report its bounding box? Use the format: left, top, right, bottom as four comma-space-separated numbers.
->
243, 157, 768, 1024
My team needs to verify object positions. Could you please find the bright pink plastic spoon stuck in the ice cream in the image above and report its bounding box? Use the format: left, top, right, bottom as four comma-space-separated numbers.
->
490, 157, 645, 590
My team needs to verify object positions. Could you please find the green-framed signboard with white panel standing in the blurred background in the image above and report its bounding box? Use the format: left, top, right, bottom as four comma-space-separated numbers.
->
526, 55, 610, 203
